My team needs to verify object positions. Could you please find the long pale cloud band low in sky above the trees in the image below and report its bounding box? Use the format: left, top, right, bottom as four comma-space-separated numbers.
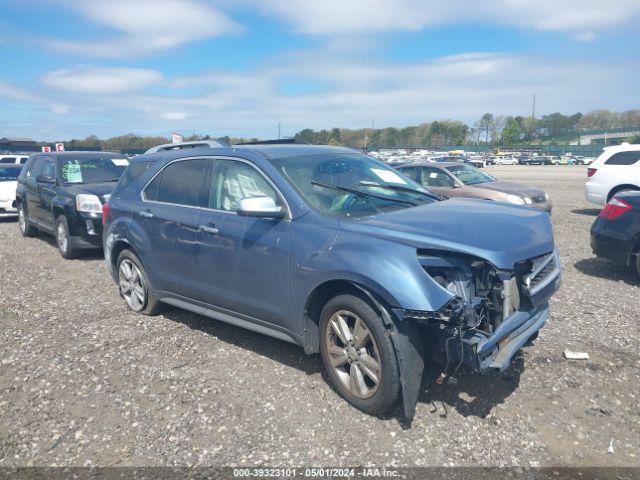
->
15, 51, 640, 142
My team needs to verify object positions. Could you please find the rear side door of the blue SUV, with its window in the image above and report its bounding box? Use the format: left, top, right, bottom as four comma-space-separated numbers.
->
134, 158, 211, 297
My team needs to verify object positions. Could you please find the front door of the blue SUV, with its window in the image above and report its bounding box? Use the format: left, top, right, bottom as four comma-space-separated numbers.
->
197, 159, 291, 328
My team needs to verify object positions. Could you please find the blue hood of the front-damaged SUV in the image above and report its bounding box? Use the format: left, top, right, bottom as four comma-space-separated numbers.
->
340, 199, 554, 270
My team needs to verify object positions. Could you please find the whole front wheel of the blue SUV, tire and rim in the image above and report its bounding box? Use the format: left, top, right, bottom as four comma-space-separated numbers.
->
320, 295, 400, 415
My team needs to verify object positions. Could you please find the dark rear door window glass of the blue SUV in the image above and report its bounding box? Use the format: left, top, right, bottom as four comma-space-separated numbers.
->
152, 159, 209, 207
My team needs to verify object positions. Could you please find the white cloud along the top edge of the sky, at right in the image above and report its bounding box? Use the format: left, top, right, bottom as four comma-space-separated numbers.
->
256, 0, 640, 34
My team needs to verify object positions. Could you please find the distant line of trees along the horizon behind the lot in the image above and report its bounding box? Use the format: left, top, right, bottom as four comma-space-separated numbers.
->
56, 109, 640, 151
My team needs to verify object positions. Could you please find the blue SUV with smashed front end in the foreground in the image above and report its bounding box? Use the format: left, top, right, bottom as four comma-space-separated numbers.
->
103, 143, 560, 419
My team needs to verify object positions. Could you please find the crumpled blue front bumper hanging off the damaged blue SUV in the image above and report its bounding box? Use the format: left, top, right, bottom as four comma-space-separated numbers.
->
463, 304, 549, 372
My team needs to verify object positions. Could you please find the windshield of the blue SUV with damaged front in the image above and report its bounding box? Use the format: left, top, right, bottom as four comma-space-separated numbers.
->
271, 153, 437, 217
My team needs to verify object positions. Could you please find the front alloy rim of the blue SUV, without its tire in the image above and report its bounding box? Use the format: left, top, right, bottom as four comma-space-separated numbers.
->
325, 310, 382, 399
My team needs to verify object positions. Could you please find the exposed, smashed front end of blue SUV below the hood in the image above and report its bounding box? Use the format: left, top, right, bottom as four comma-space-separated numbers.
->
404, 250, 560, 383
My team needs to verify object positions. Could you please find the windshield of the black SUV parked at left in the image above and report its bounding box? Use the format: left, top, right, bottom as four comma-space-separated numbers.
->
60, 157, 129, 184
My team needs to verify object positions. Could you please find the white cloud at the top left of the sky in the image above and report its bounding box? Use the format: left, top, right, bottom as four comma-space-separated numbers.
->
45, 0, 242, 58
